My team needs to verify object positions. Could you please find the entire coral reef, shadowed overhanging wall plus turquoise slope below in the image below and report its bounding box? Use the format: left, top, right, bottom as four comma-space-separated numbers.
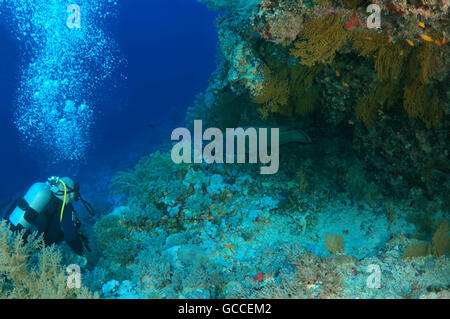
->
81, 0, 450, 298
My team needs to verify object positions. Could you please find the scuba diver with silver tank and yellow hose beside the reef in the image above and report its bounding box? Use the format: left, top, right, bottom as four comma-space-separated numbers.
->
4, 176, 93, 264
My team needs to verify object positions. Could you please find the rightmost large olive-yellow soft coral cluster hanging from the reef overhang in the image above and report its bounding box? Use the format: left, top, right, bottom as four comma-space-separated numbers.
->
352, 30, 443, 129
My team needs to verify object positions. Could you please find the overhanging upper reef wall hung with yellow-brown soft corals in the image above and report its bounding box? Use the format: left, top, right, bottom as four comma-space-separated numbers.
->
187, 0, 450, 205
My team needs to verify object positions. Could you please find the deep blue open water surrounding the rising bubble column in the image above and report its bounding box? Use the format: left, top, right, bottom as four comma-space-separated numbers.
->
0, 0, 217, 204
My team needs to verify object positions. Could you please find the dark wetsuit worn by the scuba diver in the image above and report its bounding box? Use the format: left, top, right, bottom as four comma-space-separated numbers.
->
4, 195, 83, 256
